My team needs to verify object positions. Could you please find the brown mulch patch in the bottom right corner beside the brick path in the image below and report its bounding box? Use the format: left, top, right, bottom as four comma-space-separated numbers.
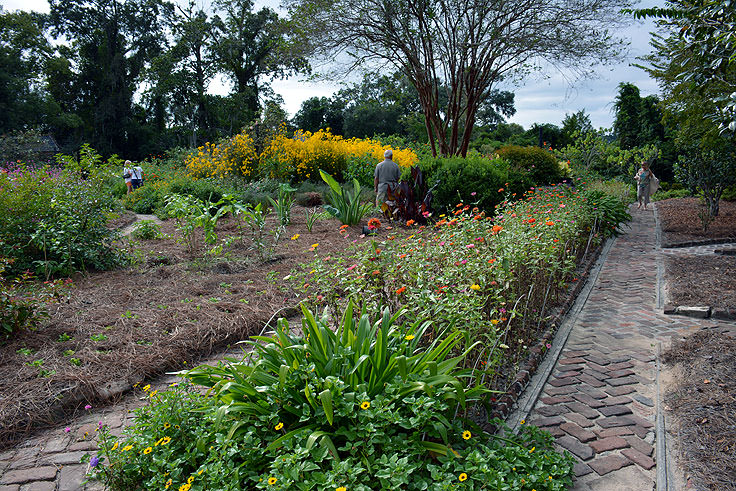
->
664, 329, 736, 491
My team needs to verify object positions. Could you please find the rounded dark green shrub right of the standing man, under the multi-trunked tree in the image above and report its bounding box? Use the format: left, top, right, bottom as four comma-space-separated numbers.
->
419, 156, 512, 210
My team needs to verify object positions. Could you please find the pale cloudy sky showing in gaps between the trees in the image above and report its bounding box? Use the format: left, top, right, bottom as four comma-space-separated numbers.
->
0, 0, 664, 129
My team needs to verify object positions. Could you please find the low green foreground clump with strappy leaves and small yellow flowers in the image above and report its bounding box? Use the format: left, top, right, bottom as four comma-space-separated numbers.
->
89, 304, 574, 490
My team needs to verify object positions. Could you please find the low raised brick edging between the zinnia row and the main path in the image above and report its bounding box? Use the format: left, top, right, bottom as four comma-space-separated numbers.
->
490, 241, 605, 420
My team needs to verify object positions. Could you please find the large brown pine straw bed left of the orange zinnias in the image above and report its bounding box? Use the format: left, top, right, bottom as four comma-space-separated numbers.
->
0, 207, 382, 448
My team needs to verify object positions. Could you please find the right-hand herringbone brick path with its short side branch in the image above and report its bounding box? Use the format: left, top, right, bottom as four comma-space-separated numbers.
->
530, 206, 723, 491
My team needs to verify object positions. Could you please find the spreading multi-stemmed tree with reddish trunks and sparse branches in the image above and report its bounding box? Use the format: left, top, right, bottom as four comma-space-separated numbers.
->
286, 0, 629, 155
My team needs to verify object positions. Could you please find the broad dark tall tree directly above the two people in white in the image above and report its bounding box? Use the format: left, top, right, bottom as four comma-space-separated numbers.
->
49, 0, 167, 157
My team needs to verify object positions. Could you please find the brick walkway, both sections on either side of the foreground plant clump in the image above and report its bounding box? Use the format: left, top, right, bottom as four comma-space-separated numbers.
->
0, 206, 736, 491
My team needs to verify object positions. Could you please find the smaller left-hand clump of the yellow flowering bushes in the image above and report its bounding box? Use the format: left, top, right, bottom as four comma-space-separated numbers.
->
184, 131, 258, 179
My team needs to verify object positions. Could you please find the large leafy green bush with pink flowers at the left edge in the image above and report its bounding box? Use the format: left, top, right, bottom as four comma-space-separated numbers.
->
0, 154, 122, 278
